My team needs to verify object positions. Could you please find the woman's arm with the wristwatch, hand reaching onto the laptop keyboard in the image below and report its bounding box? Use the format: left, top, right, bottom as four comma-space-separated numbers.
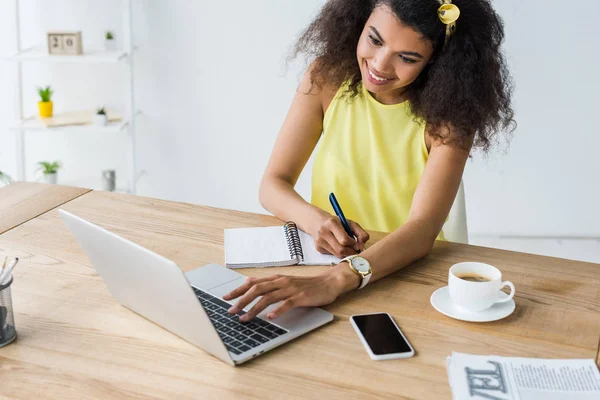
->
224, 136, 469, 320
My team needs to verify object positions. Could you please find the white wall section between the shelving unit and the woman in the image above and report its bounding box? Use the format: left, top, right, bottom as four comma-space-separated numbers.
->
136, 0, 323, 206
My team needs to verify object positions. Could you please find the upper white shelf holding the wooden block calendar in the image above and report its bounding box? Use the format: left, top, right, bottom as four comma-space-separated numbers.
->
5, 47, 129, 64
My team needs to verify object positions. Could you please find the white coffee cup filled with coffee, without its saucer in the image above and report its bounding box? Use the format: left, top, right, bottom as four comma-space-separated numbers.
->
448, 262, 515, 312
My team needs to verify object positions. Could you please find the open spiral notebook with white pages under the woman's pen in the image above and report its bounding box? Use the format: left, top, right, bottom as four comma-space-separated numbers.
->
225, 222, 340, 268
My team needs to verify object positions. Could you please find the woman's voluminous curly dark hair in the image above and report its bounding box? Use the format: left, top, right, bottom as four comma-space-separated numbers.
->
292, 0, 516, 151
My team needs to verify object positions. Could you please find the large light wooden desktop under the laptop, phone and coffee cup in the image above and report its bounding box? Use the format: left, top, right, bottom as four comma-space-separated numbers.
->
0, 192, 600, 399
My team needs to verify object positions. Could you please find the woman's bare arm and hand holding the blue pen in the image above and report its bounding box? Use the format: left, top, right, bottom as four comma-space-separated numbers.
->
259, 69, 369, 257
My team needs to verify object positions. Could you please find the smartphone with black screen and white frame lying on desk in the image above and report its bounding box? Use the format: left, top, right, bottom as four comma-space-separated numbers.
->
350, 313, 415, 360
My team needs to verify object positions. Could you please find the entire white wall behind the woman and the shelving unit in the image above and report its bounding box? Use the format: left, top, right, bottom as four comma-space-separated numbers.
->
0, 0, 600, 244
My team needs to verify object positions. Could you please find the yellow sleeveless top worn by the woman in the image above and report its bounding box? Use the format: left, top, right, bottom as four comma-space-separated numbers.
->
311, 85, 445, 240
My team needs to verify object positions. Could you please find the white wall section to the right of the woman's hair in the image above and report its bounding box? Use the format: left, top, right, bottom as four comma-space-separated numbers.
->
465, 0, 600, 238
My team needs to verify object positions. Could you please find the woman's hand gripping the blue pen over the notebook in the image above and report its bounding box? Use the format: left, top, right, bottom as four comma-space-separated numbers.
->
310, 214, 369, 258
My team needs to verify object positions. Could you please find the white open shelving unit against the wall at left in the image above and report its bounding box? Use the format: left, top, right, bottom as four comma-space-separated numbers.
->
7, 0, 142, 194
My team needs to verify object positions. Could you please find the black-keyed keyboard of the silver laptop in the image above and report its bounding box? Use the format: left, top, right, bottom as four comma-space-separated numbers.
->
192, 286, 288, 354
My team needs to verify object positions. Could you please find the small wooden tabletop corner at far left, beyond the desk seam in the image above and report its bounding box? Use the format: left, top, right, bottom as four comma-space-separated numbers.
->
0, 182, 90, 234
